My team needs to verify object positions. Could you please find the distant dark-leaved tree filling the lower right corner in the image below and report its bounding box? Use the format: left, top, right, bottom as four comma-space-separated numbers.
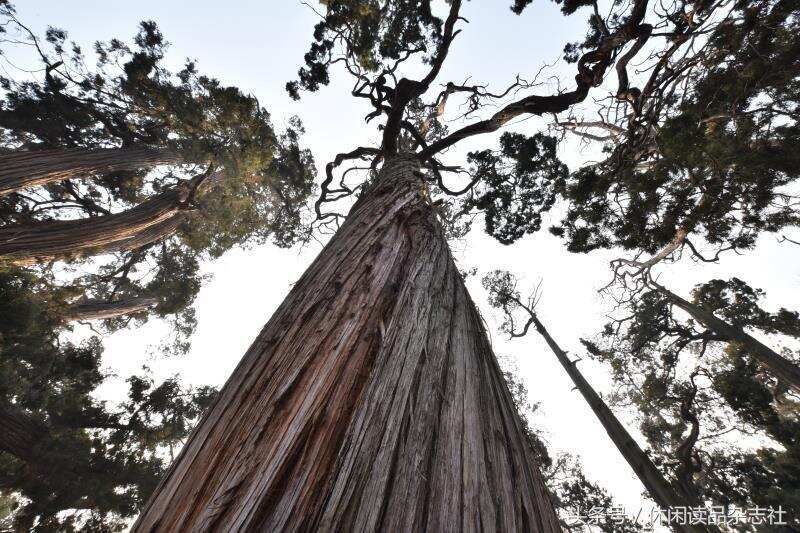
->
585, 278, 800, 531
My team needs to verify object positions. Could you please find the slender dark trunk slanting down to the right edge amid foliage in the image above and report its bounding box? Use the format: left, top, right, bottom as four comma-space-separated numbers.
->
651, 281, 800, 392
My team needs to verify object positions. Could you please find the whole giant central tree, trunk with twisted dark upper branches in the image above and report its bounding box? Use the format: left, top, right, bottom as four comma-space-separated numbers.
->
134, 0, 672, 531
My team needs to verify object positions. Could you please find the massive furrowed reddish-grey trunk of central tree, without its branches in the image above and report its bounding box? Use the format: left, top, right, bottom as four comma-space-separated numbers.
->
133, 155, 561, 532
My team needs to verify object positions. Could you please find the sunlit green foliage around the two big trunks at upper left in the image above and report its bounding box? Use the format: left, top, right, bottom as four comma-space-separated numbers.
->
0, 10, 315, 351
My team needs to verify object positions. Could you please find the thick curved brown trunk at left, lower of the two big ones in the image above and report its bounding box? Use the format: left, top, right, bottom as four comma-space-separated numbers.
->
0, 188, 186, 265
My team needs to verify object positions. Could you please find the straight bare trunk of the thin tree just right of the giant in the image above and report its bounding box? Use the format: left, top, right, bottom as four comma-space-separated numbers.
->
531, 314, 719, 533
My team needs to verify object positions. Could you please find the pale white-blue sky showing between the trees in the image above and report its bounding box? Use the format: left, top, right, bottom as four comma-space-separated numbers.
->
10, 0, 800, 524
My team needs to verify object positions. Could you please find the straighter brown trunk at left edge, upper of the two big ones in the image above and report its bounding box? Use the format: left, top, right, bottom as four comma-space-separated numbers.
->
0, 147, 181, 196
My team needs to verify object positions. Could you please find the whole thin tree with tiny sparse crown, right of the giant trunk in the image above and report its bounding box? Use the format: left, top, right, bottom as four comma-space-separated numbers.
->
483, 270, 719, 532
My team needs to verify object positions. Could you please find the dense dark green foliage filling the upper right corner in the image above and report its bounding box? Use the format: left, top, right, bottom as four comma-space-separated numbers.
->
552, 0, 800, 254
